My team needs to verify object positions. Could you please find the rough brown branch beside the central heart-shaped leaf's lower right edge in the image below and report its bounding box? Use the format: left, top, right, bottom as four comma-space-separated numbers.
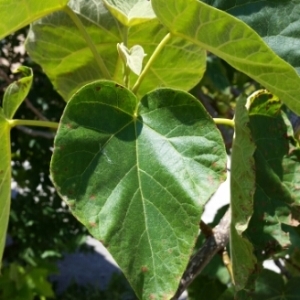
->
171, 209, 231, 300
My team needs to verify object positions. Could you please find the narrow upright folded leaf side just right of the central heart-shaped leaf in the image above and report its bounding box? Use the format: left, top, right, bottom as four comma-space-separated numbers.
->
230, 97, 256, 290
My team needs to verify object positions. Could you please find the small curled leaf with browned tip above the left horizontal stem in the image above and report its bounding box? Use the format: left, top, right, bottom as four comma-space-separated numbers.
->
3, 66, 33, 119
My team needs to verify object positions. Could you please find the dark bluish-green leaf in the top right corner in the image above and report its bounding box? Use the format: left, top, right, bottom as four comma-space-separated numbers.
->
203, 0, 300, 74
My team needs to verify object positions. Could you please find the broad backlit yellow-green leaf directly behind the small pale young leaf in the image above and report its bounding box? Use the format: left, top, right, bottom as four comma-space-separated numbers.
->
26, 0, 206, 100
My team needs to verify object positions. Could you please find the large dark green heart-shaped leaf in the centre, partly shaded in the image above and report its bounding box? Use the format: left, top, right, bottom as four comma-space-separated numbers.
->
51, 81, 226, 299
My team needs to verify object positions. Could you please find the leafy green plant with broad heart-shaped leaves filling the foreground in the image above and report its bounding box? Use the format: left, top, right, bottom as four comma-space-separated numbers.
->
0, 0, 300, 299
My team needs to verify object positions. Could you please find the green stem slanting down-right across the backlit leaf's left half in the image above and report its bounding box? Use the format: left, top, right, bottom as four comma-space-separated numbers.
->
64, 5, 111, 79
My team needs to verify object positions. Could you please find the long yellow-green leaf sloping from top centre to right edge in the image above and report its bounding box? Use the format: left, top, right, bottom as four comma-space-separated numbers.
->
151, 0, 300, 114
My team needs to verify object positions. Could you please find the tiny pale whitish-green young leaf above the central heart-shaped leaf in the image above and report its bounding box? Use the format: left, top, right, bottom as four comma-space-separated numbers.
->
117, 43, 146, 75
